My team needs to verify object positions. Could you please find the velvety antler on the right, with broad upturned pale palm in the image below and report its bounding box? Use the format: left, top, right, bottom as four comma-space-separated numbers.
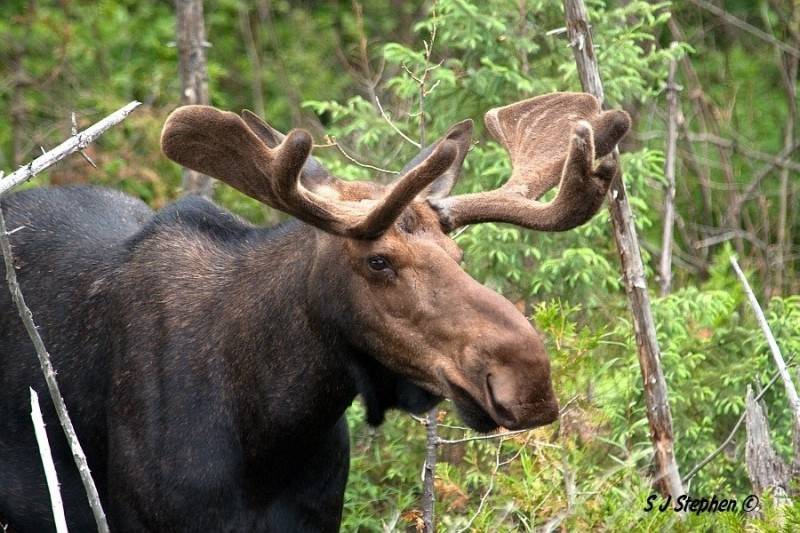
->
429, 93, 630, 231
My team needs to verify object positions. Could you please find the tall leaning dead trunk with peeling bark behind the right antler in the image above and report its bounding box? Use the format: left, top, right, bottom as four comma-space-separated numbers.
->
564, 0, 683, 498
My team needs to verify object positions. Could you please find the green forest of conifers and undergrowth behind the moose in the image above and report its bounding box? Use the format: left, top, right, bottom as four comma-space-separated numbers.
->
0, 0, 800, 531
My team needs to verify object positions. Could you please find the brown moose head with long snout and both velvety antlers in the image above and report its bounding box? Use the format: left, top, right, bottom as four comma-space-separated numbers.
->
161, 93, 630, 431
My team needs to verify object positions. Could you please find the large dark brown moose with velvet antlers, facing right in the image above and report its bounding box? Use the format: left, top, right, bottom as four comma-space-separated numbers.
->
0, 93, 630, 532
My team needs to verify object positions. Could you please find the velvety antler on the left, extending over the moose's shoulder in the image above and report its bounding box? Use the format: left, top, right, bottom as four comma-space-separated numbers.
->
161, 105, 459, 239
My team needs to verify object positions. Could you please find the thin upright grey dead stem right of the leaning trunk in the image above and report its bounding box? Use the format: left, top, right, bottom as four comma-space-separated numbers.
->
659, 59, 678, 296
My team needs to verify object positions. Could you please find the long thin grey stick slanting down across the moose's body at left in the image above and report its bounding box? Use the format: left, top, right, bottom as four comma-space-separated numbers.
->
0, 208, 108, 533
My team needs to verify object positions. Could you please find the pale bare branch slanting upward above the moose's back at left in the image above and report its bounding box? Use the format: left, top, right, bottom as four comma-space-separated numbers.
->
0, 100, 141, 197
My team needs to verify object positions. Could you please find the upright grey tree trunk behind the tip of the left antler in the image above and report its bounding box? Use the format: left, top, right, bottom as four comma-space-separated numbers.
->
175, 0, 214, 198
